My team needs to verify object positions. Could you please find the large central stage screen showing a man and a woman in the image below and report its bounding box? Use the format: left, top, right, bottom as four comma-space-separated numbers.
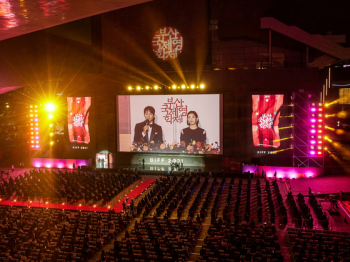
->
117, 94, 223, 154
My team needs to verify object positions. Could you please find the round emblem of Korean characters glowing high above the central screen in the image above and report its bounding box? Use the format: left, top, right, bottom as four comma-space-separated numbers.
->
152, 27, 183, 61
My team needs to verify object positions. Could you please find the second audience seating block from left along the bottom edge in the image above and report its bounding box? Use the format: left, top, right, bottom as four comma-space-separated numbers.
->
103, 216, 202, 262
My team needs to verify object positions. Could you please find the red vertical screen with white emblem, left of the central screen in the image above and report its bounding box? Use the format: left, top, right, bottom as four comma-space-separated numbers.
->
67, 97, 91, 144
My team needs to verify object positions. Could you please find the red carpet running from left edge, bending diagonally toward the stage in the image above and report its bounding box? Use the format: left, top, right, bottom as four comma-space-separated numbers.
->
0, 179, 155, 212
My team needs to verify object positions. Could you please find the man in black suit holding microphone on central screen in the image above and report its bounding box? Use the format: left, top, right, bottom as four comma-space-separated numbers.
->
134, 106, 163, 144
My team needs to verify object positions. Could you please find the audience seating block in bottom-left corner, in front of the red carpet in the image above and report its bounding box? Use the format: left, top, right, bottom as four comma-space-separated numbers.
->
0, 206, 130, 262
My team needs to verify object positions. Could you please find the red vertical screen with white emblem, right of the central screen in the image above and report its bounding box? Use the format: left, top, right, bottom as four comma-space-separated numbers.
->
251, 94, 293, 158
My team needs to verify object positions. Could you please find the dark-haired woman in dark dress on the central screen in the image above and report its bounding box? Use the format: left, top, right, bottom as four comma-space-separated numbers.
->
180, 111, 207, 146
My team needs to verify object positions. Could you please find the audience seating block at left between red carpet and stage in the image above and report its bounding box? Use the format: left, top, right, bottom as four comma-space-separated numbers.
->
0, 170, 139, 205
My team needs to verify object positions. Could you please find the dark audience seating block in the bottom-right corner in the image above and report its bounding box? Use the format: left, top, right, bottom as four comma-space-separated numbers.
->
286, 228, 350, 262
